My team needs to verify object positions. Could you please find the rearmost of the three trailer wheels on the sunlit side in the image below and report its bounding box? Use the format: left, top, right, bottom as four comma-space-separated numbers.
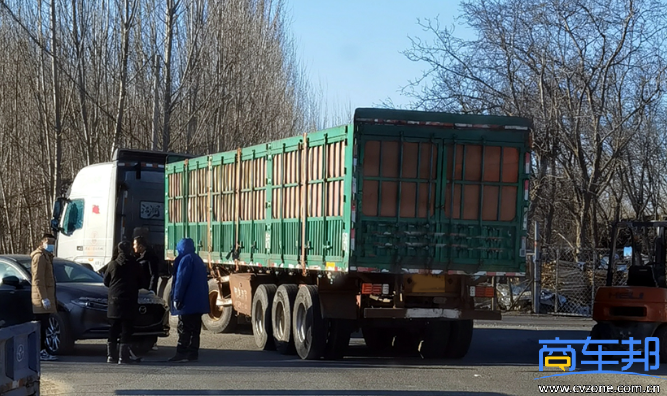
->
292, 285, 327, 360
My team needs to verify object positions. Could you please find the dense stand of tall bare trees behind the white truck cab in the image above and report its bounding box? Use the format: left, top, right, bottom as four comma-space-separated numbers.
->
0, 0, 322, 252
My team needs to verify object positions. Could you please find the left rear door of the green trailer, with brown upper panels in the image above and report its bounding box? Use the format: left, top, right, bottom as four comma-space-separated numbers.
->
357, 135, 443, 272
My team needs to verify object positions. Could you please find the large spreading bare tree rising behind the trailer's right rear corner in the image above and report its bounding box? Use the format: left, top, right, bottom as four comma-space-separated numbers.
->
406, 0, 667, 245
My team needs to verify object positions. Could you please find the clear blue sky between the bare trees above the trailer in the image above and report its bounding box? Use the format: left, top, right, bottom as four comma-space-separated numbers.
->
286, 0, 470, 120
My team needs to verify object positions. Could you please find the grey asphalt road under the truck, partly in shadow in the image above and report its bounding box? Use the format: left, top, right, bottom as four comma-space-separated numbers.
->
41, 316, 667, 396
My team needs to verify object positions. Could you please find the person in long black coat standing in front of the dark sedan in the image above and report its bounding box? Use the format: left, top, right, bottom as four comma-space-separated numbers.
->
104, 241, 141, 364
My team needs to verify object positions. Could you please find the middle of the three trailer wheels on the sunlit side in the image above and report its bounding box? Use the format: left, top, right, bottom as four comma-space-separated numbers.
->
271, 285, 299, 355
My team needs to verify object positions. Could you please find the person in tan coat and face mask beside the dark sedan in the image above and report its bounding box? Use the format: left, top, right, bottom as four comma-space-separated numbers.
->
30, 234, 58, 361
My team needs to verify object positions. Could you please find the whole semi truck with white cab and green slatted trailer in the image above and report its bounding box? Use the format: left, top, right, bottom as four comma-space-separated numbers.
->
53, 108, 532, 359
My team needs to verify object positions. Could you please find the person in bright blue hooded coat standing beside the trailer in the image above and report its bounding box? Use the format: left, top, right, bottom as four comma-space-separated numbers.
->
169, 238, 209, 362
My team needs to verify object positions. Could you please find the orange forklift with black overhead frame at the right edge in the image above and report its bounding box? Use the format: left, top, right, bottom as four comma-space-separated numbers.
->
590, 221, 667, 363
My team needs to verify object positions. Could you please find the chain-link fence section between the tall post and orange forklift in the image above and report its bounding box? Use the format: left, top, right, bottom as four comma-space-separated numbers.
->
539, 246, 628, 316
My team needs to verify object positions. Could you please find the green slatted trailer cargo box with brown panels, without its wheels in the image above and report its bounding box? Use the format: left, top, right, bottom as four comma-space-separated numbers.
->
165, 109, 530, 274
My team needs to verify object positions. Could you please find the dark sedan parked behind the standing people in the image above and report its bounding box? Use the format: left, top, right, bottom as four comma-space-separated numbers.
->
0, 255, 169, 355
